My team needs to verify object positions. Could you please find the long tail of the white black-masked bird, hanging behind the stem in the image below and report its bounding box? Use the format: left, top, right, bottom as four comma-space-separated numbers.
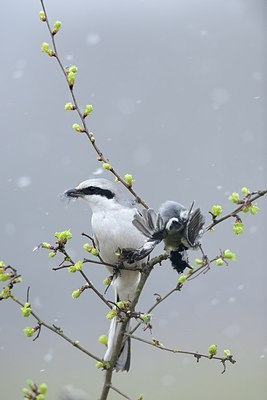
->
104, 317, 131, 372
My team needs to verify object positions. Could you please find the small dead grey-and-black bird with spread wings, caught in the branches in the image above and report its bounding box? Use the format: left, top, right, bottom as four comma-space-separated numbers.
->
121, 201, 205, 273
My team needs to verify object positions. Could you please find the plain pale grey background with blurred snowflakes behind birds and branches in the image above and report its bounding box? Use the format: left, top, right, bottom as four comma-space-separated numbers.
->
0, 0, 267, 400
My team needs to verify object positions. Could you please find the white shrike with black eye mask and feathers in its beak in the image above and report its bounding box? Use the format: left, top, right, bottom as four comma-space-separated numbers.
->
64, 179, 149, 371
